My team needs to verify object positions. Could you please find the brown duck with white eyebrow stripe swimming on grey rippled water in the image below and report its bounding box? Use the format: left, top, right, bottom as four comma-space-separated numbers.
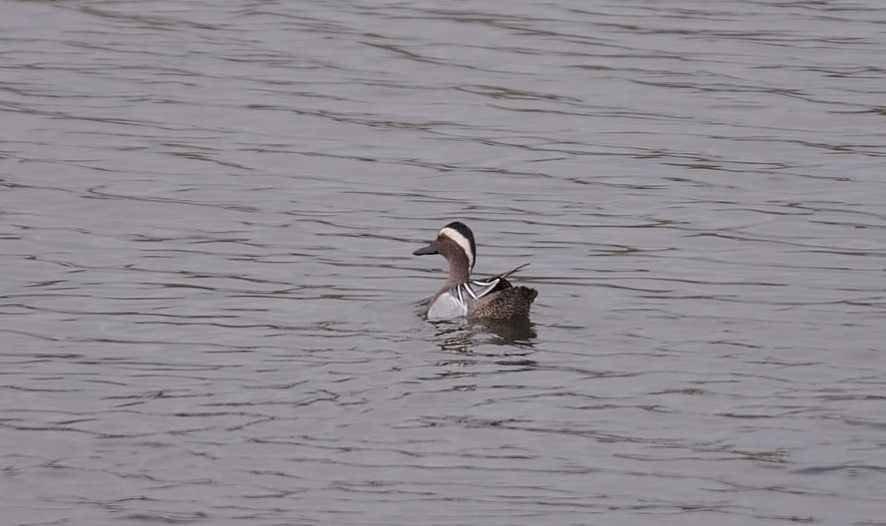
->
412, 221, 538, 320
